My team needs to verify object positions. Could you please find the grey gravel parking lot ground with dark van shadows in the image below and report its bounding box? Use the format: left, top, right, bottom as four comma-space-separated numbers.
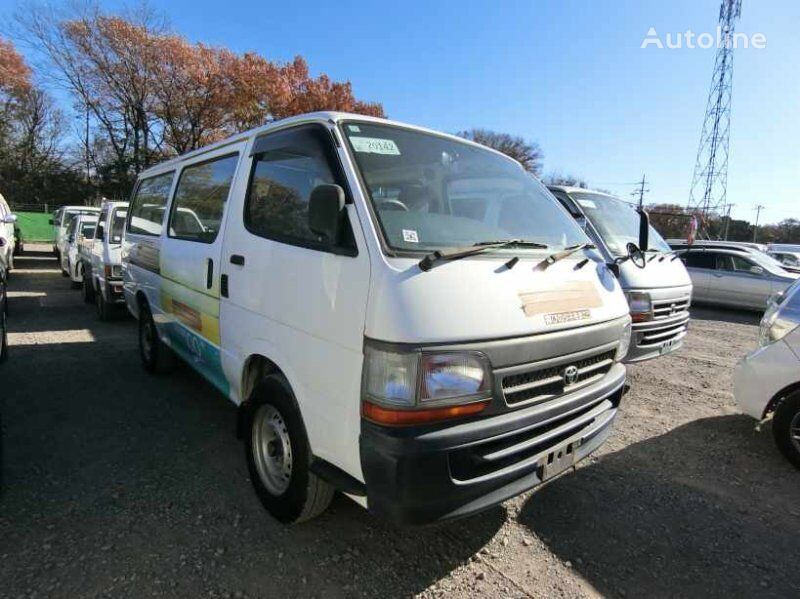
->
0, 246, 800, 598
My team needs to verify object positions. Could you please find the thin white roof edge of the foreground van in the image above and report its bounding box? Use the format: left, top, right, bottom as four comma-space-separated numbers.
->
139, 111, 520, 178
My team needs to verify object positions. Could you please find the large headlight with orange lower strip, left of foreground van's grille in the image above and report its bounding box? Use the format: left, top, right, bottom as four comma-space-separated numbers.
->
362, 345, 492, 424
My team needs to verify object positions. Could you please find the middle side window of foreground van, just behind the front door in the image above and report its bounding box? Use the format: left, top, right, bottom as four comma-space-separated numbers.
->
169, 154, 239, 243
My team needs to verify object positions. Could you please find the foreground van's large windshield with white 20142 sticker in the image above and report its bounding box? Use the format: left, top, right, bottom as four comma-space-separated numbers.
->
343, 122, 588, 252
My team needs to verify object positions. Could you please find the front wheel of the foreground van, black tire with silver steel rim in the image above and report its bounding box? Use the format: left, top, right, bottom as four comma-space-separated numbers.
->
245, 375, 334, 524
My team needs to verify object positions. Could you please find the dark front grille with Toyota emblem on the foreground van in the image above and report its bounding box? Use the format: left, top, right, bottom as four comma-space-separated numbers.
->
501, 349, 616, 405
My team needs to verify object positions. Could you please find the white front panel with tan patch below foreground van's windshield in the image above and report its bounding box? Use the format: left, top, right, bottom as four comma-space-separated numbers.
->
365, 253, 628, 343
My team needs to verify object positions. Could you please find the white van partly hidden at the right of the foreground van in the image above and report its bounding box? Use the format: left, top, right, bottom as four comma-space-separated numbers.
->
548, 185, 692, 362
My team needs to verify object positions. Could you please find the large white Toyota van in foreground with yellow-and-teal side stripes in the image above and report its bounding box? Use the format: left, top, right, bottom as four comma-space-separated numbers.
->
122, 113, 630, 524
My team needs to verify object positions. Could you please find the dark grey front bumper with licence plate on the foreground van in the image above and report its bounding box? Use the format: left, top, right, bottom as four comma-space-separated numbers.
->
360, 364, 625, 525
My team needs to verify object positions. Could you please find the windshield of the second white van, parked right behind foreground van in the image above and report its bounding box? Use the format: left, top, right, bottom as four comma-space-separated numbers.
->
570, 191, 671, 256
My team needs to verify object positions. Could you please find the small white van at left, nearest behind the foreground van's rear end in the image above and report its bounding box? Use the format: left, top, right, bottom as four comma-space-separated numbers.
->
81, 201, 128, 320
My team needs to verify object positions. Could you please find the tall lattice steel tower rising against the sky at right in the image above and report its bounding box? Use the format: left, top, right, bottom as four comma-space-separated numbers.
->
688, 0, 742, 222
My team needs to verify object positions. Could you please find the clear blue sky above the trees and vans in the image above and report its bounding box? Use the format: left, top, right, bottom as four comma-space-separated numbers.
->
0, 0, 800, 222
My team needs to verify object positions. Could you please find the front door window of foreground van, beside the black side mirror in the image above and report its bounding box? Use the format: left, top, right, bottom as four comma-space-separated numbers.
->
244, 125, 348, 247
